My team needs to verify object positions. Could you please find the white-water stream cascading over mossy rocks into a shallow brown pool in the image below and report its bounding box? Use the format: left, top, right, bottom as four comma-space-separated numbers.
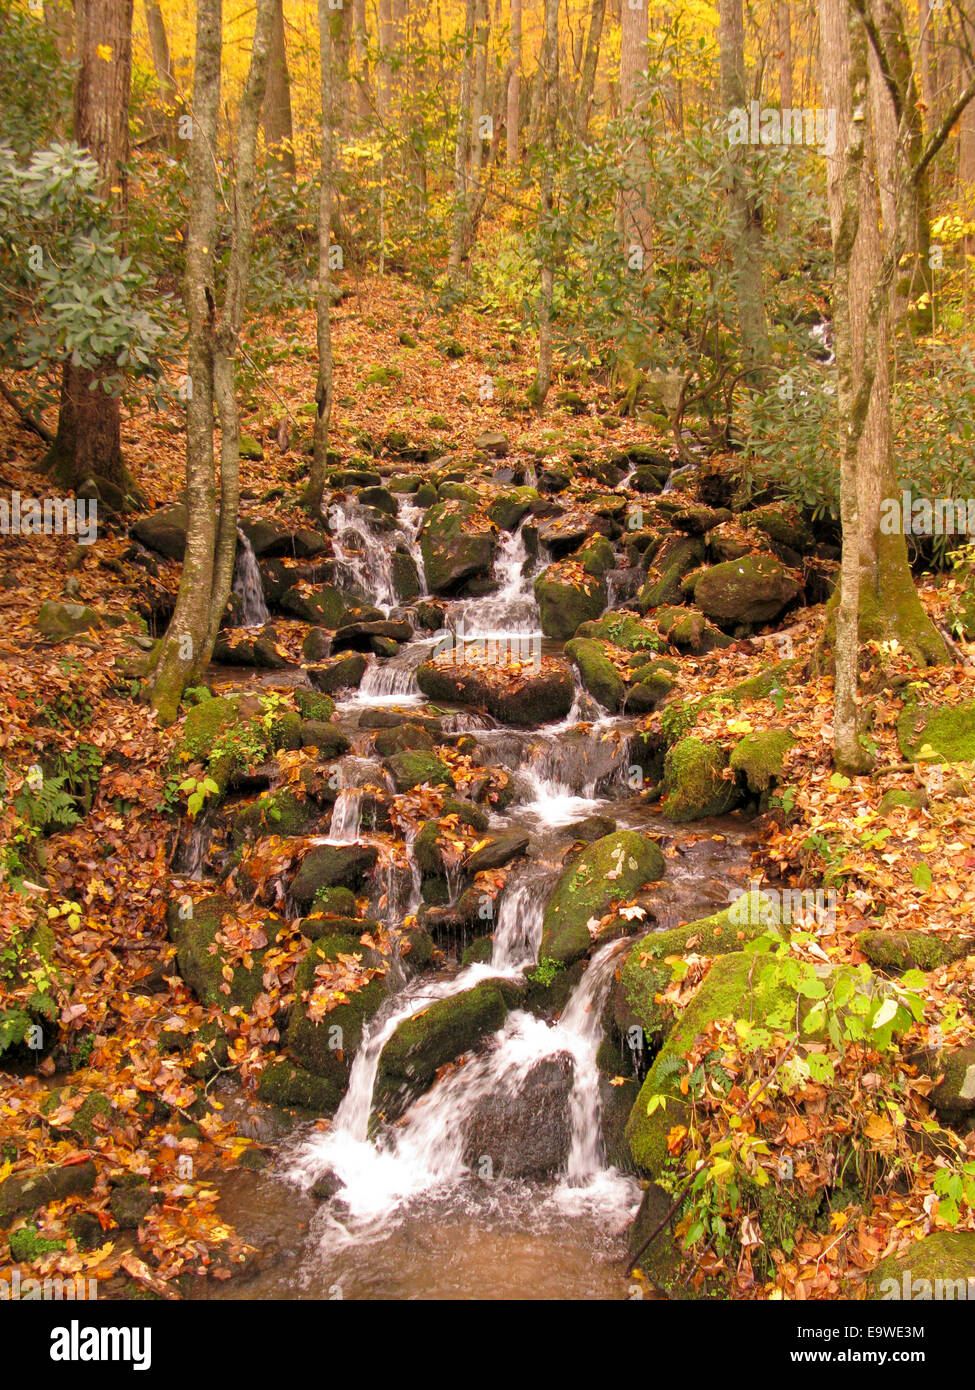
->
196, 507, 755, 1300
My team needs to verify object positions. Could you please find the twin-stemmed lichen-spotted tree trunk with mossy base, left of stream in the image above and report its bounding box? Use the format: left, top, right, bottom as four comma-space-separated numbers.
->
149, 0, 274, 723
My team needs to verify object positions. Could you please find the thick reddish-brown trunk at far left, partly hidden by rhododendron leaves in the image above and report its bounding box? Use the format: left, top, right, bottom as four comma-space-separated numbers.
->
43, 0, 135, 512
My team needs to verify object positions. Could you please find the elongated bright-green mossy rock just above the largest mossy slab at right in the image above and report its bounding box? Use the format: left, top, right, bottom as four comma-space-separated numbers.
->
616, 891, 779, 1045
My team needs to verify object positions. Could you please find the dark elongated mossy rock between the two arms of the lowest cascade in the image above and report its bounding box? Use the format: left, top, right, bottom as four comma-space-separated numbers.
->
373, 980, 508, 1120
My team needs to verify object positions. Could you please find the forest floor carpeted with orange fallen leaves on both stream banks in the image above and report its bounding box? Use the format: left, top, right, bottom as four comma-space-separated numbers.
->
0, 279, 975, 1298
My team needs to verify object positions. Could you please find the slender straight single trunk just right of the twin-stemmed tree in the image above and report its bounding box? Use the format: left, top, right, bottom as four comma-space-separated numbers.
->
303, 0, 335, 516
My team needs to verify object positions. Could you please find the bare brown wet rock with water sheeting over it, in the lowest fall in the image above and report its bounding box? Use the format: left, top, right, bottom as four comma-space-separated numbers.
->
463, 1052, 573, 1177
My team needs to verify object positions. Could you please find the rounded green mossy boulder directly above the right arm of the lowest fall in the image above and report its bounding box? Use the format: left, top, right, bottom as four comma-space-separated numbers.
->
538, 830, 666, 965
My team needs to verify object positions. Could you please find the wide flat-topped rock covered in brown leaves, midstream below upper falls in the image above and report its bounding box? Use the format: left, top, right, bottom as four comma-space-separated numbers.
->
416, 653, 574, 728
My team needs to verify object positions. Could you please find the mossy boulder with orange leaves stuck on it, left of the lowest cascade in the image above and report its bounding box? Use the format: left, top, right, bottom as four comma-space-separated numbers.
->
287, 933, 387, 1099
